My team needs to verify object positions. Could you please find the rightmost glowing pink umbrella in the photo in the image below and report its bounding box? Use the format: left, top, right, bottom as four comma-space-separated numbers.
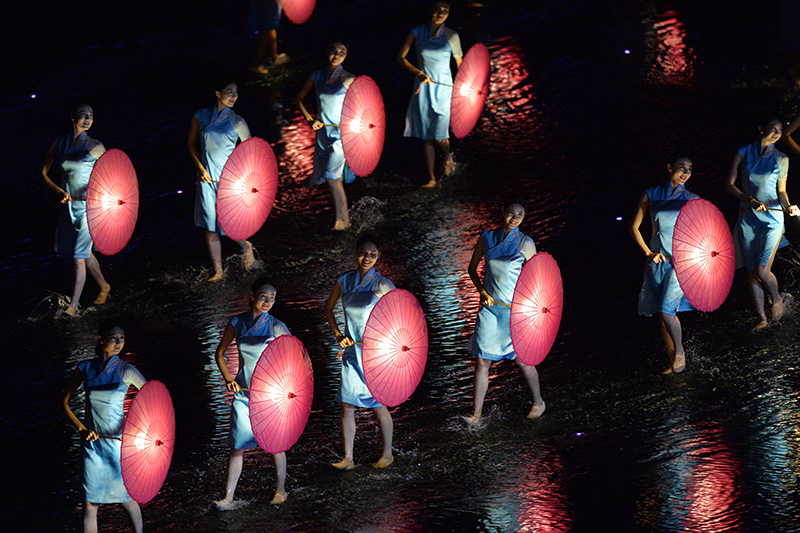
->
672, 199, 736, 311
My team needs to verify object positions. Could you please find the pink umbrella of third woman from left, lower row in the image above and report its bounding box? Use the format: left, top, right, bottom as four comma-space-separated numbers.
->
361, 289, 428, 407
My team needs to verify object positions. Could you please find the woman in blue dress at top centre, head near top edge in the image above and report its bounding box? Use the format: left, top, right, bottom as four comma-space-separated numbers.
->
397, 2, 463, 187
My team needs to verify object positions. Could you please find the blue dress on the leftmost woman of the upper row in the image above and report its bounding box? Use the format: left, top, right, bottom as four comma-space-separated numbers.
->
53, 131, 105, 259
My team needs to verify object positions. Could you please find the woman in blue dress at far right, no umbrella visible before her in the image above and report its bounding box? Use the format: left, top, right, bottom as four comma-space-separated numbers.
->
725, 119, 800, 331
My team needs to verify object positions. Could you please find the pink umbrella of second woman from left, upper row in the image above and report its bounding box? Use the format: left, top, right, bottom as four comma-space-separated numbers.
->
217, 137, 278, 241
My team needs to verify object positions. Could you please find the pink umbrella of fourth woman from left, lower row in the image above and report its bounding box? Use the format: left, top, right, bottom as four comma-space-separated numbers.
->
511, 252, 564, 366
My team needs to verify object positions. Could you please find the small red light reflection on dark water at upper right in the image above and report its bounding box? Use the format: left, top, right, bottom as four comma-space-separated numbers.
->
647, 11, 695, 85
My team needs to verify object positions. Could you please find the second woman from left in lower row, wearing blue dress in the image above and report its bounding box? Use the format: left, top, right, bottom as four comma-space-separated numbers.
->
215, 279, 289, 511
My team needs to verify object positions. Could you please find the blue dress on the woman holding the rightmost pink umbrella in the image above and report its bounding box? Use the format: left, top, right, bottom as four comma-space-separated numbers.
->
639, 181, 699, 316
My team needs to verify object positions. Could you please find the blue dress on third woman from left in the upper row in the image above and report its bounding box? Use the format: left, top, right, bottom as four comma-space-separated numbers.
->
311, 65, 356, 185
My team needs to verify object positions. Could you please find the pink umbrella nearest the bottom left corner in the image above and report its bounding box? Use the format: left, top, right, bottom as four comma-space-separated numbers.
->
120, 380, 175, 503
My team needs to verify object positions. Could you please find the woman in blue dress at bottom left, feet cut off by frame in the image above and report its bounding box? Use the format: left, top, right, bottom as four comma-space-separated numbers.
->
61, 320, 146, 532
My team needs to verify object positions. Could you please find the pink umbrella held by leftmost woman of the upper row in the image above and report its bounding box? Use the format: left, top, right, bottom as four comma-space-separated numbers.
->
86, 148, 139, 255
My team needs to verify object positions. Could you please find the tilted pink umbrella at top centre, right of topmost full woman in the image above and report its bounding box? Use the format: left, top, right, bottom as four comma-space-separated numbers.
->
450, 43, 490, 139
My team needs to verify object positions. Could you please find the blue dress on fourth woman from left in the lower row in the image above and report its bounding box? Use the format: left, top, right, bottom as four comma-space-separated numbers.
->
467, 227, 536, 361
